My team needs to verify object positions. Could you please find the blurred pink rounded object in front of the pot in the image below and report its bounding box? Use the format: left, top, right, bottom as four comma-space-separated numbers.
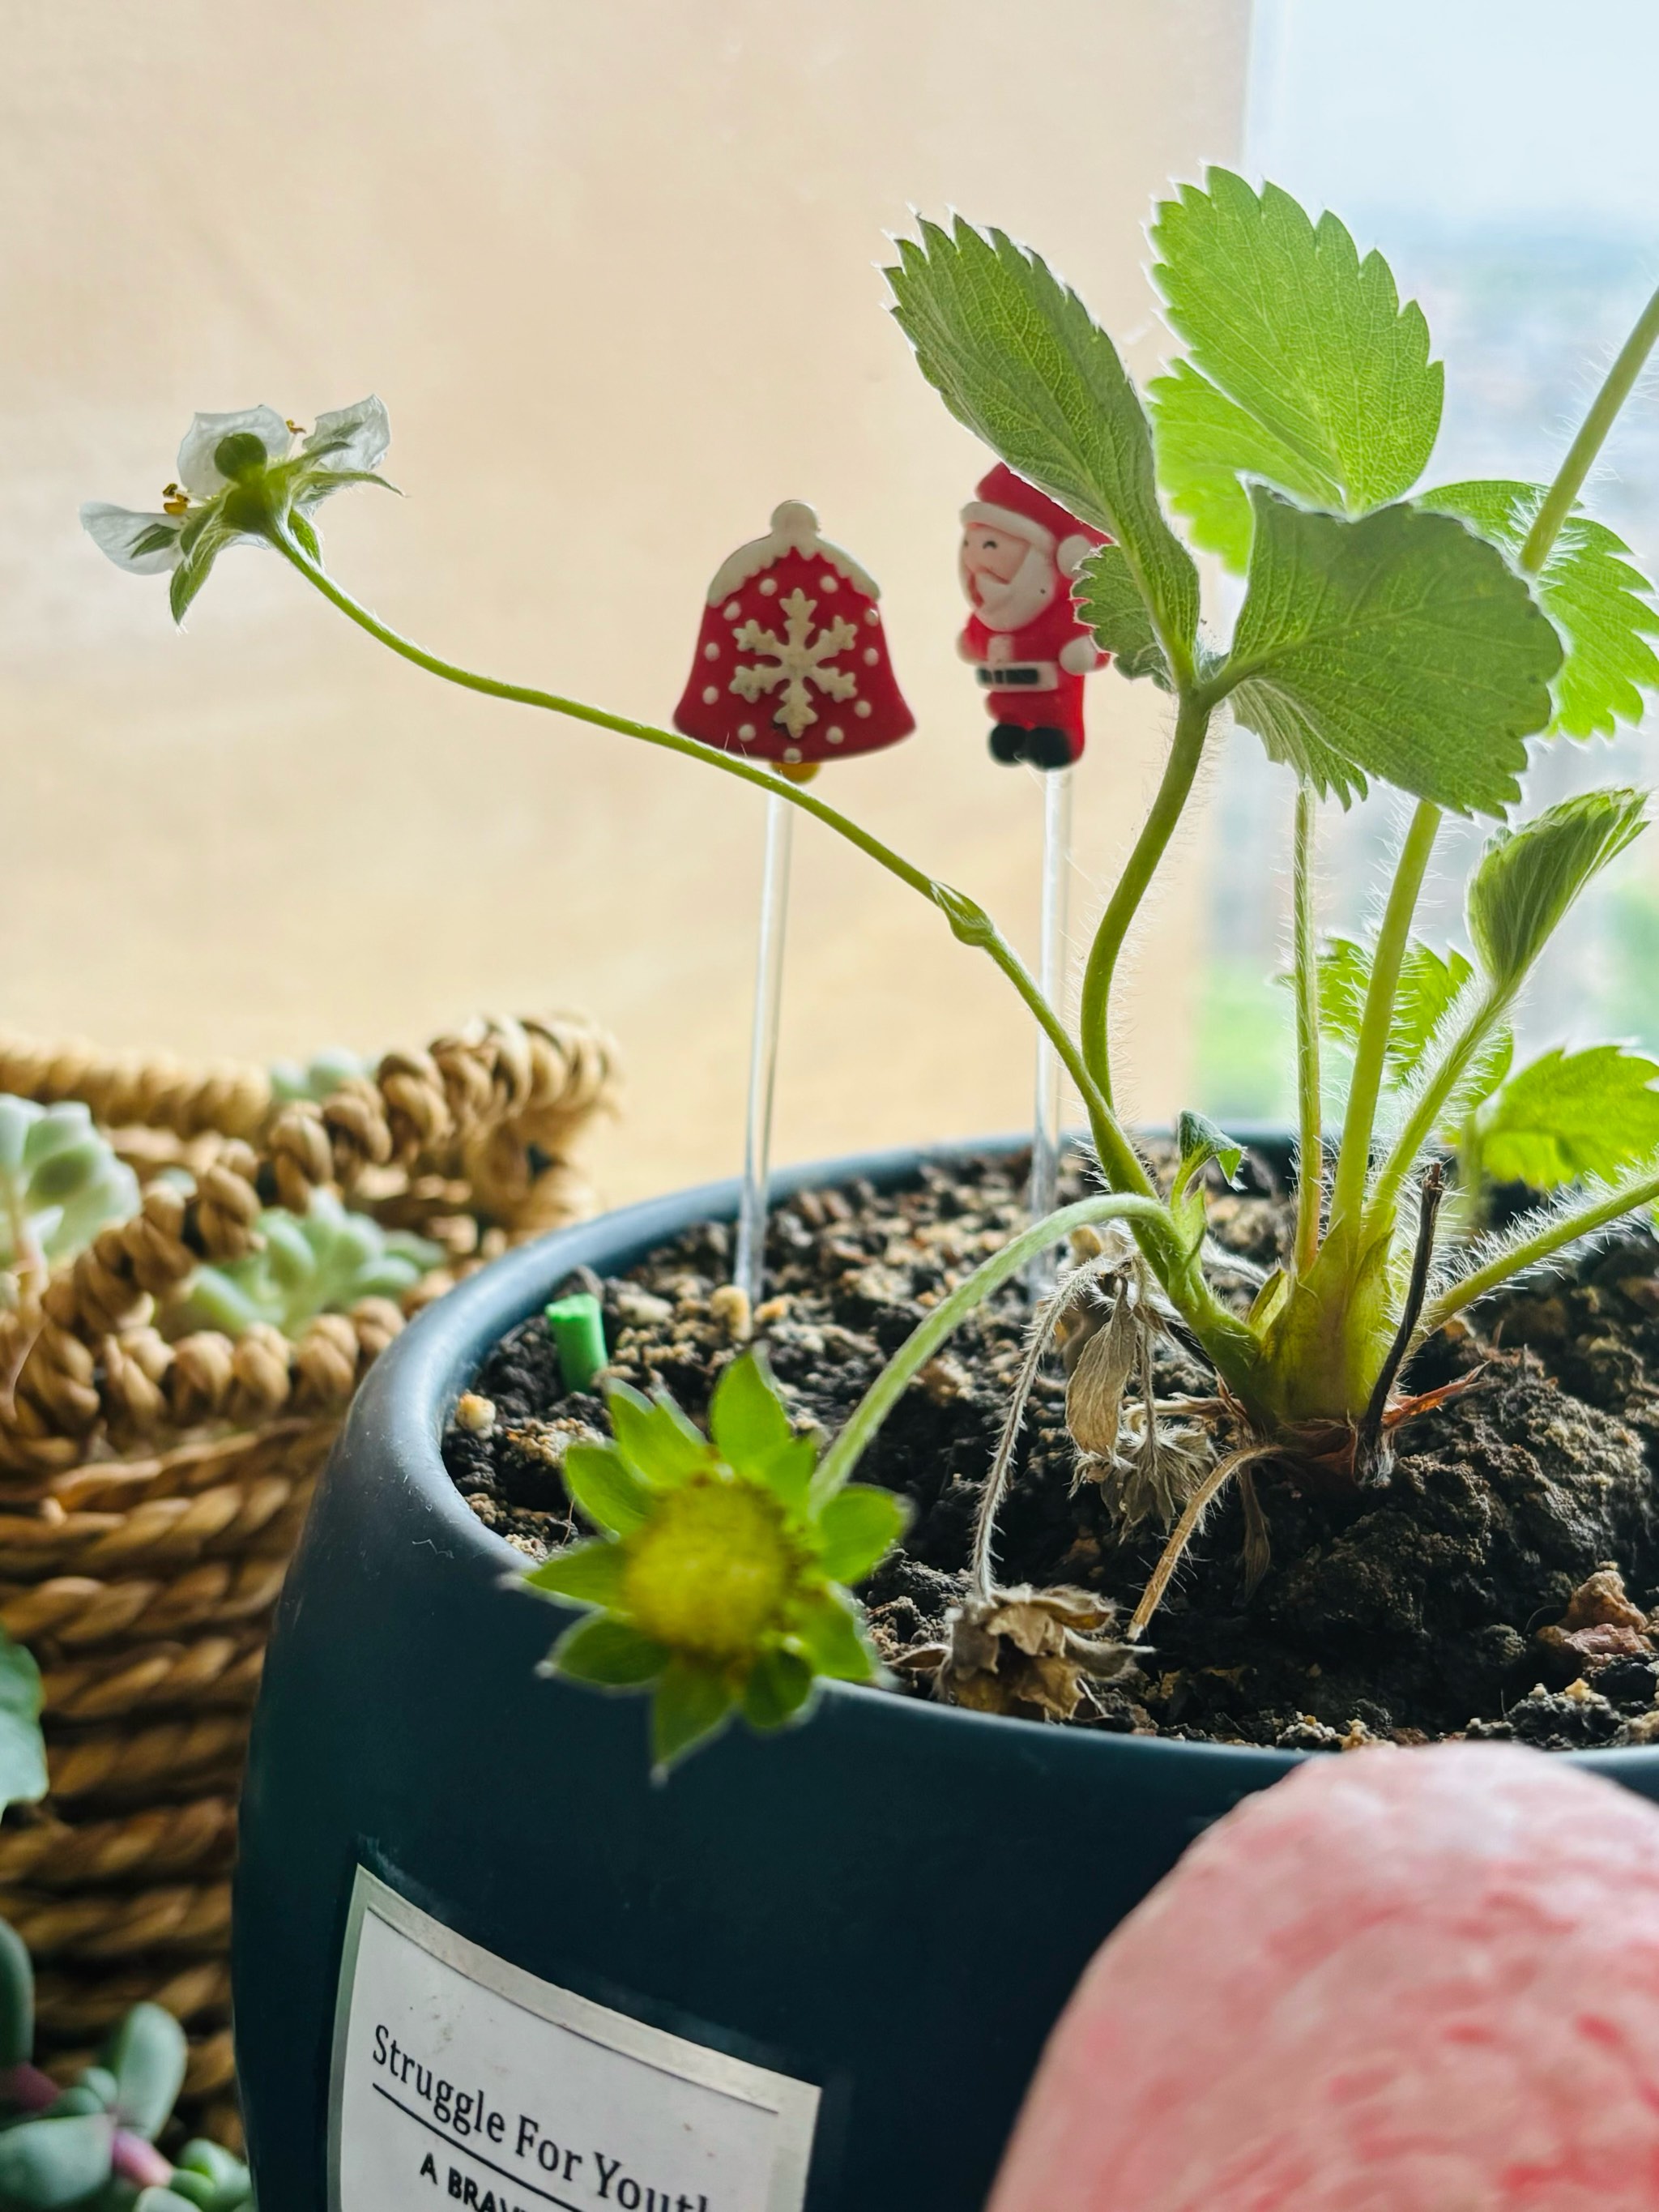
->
991, 1743, 1659, 2212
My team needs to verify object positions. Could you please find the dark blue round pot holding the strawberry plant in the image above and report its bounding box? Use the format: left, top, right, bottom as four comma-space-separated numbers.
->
234, 1148, 1659, 2212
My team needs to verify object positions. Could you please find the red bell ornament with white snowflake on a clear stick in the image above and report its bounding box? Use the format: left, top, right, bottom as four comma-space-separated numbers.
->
675, 500, 915, 783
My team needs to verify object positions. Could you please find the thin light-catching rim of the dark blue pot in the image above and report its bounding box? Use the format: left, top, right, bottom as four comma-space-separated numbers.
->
360, 1121, 1659, 1779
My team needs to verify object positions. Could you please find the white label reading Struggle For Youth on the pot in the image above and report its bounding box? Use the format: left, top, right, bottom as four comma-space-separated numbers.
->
330, 1867, 818, 2212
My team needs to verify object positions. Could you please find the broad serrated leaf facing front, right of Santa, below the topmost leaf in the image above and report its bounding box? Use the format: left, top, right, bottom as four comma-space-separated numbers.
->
1217, 485, 1562, 814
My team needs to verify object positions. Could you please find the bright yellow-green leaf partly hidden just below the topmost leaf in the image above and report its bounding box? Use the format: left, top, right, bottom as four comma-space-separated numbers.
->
1145, 361, 1343, 575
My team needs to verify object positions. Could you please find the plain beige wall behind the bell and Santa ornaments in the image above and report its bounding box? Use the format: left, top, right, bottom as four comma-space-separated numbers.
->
0, 0, 1247, 1197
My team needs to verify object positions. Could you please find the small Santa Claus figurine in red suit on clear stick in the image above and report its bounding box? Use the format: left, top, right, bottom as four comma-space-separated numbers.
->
957, 463, 1106, 767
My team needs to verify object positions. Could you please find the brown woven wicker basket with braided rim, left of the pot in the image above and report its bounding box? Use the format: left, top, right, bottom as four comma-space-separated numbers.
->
0, 1020, 615, 2142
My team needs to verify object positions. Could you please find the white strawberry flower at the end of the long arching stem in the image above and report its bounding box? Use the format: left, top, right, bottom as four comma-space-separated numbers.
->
79, 396, 394, 621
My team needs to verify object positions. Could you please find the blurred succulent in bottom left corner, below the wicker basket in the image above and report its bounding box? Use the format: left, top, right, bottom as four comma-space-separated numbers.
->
0, 1920, 252, 2212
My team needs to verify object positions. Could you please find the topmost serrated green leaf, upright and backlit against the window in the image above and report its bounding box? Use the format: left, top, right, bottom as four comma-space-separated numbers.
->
1153, 168, 1444, 515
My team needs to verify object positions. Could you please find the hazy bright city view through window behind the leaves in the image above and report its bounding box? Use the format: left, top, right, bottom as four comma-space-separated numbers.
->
1195, 0, 1659, 1119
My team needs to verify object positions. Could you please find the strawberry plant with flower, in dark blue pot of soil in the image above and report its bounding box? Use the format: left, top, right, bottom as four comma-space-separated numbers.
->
88, 170, 1659, 2212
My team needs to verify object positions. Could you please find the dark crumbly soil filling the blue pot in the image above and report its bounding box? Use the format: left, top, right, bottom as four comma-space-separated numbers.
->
445, 1157, 1659, 1749
